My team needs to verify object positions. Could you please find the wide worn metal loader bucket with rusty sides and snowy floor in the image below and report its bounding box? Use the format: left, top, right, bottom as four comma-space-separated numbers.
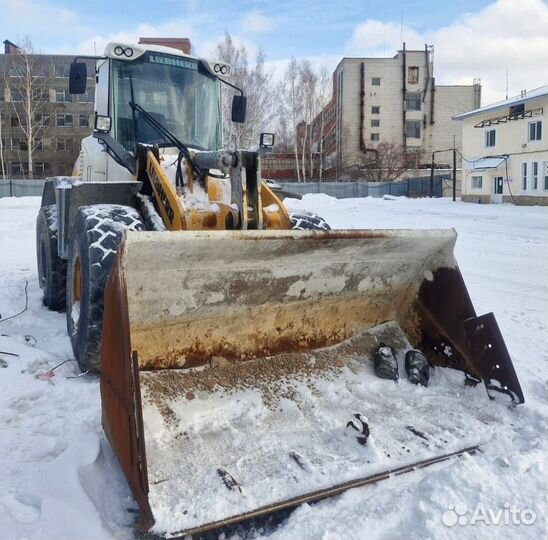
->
101, 230, 523, 536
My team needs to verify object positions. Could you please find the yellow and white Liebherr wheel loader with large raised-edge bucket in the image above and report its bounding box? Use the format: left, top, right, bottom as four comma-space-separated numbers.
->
37, 43, 523, 537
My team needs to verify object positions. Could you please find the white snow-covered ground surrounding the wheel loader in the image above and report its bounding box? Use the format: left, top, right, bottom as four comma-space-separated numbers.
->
0, 195, 548, 540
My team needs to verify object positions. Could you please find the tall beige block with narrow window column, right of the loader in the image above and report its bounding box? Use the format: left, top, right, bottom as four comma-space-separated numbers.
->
312, 44, 481, 178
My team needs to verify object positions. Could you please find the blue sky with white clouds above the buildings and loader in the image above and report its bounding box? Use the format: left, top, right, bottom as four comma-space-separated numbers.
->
0, 0, 548, 104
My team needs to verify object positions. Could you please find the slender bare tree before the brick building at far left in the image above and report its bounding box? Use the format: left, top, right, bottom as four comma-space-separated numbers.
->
6, 37, 49, 178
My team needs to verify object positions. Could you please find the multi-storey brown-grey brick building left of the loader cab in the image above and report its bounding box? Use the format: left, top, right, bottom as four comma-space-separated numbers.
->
0, 40, 95, 178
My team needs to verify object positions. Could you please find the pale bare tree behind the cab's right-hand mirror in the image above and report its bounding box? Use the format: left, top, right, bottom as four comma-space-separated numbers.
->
216, 33, 273, 149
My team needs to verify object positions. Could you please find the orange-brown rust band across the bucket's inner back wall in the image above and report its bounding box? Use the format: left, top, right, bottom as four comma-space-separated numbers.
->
131, 293, 398, 369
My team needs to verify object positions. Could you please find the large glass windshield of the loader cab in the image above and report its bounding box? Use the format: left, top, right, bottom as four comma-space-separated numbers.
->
112, 52, 221, 151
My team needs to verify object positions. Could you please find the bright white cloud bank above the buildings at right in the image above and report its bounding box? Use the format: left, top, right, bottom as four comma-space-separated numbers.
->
347, 0, 548, 104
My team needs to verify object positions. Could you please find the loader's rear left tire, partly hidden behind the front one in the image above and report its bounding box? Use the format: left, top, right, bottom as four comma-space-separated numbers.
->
36, 204, 67, 311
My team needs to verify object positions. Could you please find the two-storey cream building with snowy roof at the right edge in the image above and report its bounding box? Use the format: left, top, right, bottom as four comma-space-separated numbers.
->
455, 86, 548, 205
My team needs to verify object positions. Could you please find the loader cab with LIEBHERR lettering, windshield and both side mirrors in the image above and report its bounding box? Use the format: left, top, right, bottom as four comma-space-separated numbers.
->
70, 43, 245, 156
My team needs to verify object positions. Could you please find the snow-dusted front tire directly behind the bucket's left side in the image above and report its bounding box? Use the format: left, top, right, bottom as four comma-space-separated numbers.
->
66, 204, 145, 372
